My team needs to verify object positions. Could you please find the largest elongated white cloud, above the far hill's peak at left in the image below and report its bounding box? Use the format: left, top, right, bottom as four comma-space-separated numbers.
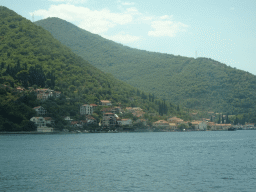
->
31, 4, 133, 34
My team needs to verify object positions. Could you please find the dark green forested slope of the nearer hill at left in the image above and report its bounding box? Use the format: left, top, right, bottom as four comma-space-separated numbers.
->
0, 7, 190, 131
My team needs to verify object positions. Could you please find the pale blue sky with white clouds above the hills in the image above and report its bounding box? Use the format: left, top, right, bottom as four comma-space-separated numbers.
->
0, 0, 256, 75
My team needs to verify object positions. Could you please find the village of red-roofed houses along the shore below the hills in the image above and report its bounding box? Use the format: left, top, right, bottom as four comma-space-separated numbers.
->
23, 87, 254, 133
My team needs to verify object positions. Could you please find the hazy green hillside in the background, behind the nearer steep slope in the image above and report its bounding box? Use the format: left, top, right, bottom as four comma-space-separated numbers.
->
36, 18, 256, 114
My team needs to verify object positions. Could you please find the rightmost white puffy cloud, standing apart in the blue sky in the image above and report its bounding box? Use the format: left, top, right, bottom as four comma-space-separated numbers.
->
148, 16, 188, 37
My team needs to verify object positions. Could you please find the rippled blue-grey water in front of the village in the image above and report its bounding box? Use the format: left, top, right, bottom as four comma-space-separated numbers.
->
0, 131, 256, 192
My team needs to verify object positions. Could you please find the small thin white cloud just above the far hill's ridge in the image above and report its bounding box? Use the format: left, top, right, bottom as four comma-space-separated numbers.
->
103, 32, 142, 43
